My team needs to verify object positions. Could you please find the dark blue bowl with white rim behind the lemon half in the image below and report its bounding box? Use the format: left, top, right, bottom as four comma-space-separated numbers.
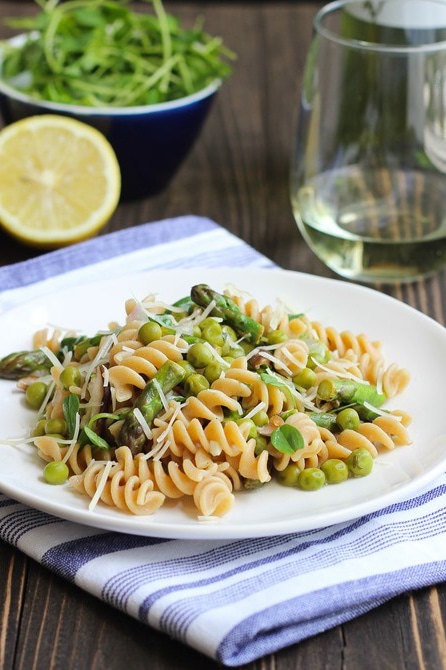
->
0, 69, 221, 200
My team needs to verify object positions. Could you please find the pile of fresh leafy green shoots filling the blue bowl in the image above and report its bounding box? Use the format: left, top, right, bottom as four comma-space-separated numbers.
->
1, 0, 235, 107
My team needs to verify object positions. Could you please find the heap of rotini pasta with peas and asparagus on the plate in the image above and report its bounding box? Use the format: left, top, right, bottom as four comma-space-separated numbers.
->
0, 285, 411, 518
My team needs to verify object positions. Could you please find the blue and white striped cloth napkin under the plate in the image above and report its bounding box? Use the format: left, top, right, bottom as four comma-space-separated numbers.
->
0, 217, 446, 666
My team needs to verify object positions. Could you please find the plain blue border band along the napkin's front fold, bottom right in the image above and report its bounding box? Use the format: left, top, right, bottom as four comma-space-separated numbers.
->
216, 561, 445, 667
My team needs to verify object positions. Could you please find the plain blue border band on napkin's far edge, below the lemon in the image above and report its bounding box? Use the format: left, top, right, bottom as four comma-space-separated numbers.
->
0, 216, 219, 291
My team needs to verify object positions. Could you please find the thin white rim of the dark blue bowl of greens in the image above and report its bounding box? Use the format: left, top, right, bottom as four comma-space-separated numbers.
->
0, 33, 222, 116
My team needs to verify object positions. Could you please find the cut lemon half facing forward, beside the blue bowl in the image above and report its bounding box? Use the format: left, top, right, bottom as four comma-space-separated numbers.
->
0, 114, 121, 249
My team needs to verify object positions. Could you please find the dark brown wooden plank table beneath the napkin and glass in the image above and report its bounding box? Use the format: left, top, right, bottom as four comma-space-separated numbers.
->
0, 0, 446, 670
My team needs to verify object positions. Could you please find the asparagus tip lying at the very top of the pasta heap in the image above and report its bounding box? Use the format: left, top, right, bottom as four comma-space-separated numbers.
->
190, 284, 264, 344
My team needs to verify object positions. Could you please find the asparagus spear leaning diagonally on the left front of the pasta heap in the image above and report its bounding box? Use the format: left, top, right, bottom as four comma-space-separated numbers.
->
119, 361, 185, 455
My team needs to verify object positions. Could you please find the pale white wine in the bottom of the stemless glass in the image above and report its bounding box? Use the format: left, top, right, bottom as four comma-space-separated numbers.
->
292, 166, 446, 283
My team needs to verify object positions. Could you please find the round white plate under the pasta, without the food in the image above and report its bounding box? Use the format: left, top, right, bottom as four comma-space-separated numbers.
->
0, 269, 446, 539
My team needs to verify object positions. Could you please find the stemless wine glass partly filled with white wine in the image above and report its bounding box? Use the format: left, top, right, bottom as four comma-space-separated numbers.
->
291, 0, 446, 283
